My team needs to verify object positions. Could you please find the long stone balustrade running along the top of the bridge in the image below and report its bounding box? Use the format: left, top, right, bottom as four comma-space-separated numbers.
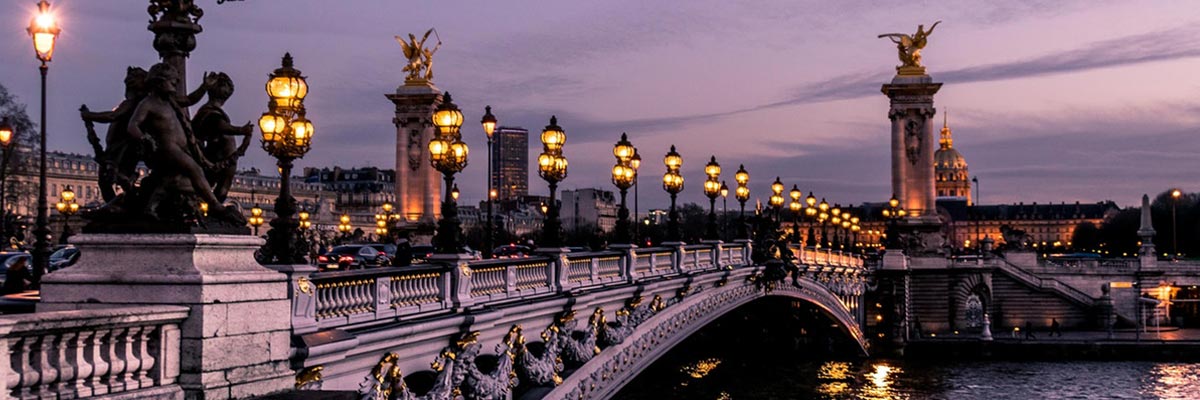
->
283, 243, 863, 334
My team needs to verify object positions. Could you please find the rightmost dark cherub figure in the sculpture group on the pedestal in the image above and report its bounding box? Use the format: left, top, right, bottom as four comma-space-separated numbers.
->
192, 72, 254, 202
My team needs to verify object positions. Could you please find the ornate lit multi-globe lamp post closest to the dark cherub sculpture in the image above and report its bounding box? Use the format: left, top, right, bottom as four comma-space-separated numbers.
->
258, 53, 313, 264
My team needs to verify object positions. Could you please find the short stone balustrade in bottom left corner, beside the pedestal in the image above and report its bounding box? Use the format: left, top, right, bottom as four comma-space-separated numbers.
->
0, 305, 188, 399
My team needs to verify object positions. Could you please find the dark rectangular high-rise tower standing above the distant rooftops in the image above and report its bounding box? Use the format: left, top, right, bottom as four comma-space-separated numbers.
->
491, 126, 529, 199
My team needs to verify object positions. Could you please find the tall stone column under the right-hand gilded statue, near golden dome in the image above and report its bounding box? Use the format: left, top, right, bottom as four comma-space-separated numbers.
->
882, 74, 942, 220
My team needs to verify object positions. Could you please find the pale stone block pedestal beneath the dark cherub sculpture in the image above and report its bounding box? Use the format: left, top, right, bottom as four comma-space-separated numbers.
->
37, 234, 294, 399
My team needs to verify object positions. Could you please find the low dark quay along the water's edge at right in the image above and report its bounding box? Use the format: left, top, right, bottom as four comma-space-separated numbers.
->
902, 329, 1200, 362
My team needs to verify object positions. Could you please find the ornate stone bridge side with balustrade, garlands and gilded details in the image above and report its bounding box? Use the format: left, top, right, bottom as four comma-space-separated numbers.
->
283, 243, 866, 399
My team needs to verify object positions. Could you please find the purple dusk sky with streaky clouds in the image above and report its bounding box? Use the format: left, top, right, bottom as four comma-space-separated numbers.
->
0, 0, 1200, 210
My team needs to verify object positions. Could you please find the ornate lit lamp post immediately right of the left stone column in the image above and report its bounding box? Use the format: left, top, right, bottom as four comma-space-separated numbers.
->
430, 92, 469, 253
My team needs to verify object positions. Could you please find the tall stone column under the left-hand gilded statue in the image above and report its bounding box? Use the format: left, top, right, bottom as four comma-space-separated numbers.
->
386, 82, 442, 243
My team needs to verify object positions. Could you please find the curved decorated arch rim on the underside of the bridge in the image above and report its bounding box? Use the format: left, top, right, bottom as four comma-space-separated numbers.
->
545, 274, 868, 399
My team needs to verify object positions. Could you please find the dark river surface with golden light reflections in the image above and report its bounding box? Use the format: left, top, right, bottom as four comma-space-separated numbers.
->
616, 356, 1200, 400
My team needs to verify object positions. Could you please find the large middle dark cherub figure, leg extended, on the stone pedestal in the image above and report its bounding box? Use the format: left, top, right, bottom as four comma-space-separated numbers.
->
128, 62, 245, 223
